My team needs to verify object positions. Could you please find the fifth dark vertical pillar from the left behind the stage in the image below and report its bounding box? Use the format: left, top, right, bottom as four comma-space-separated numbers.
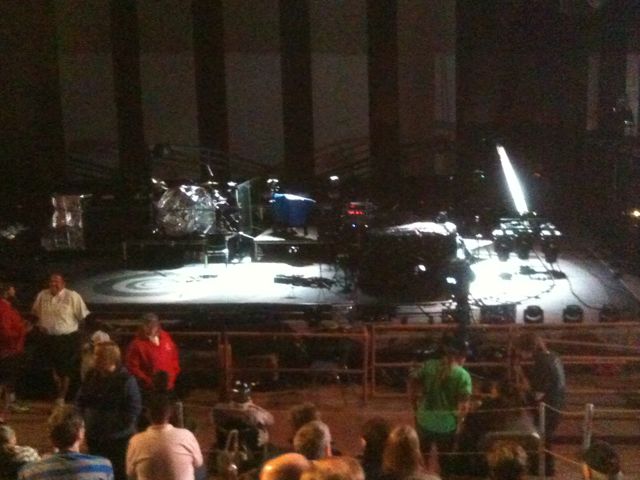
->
367, 0, 400, 204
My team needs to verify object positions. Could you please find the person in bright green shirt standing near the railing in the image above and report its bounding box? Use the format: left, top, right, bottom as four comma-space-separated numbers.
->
409, 337, 472, 475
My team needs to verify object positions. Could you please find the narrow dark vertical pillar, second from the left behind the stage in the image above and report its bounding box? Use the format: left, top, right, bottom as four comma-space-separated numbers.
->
111, 0, 150, 197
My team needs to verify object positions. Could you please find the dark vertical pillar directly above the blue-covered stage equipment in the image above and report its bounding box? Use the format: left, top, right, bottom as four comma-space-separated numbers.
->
279, 0, 314, 191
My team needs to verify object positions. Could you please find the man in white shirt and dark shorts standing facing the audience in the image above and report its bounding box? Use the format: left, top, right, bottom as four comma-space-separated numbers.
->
31, 273, 89, 404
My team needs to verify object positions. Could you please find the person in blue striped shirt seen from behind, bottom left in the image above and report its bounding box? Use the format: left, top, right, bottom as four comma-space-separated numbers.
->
18, 406, 113, 480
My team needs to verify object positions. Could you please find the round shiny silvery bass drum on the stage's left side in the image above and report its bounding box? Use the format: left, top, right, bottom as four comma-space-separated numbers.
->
156, 185, 216, 237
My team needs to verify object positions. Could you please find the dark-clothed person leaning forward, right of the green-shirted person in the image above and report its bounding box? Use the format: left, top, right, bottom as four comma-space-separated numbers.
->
516, 332, 566, 476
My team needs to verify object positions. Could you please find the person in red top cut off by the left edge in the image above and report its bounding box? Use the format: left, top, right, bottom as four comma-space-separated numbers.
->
0, 282, 28, 421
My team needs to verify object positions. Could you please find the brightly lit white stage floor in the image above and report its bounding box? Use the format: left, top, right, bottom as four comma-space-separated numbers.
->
70, 240, 640, 323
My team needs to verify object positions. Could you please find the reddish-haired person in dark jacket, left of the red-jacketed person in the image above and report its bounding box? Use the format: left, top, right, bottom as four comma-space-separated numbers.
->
76, 342, 142, 480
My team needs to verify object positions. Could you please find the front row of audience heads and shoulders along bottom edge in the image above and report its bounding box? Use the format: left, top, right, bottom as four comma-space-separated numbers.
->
0, 394, 622, 480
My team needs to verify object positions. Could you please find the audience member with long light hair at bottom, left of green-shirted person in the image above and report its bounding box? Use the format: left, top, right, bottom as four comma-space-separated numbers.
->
380, 425, 439, 480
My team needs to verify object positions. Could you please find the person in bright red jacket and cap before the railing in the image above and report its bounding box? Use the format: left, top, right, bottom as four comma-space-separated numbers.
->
125, 313, 180, 392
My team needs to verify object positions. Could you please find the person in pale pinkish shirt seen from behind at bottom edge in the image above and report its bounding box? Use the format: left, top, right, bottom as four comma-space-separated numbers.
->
127, 394, 205, 480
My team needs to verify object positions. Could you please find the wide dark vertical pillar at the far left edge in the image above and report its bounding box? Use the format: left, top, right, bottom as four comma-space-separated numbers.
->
0, 0, 65, 214
